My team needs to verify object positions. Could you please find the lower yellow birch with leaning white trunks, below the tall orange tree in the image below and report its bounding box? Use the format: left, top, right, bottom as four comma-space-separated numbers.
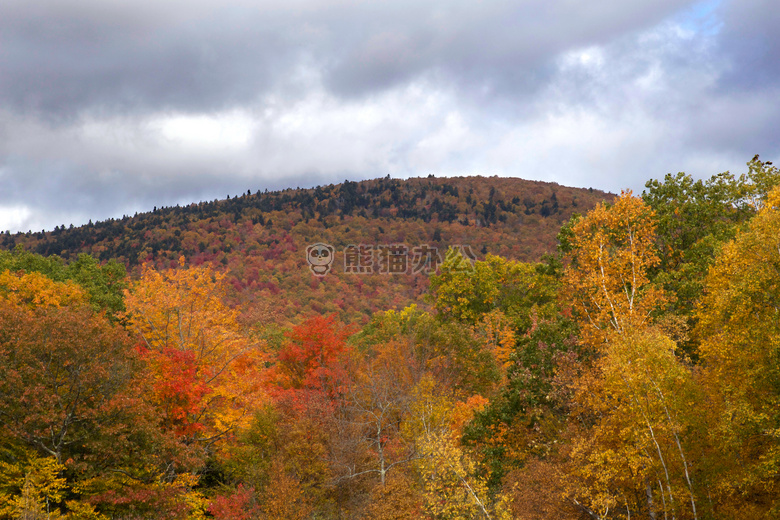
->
568, 329, 700, 518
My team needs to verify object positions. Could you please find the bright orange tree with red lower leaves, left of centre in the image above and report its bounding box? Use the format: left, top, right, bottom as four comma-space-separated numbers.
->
125, 258, 263, 445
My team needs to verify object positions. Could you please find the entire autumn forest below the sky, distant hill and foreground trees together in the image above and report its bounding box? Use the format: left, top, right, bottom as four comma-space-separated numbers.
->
0, 156, 780, 520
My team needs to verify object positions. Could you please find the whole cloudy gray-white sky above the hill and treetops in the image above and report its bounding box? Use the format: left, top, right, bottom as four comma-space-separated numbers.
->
0, 0, 780, 231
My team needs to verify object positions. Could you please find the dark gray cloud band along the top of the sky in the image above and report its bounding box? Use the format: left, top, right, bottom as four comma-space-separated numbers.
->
0, 0, 687, 116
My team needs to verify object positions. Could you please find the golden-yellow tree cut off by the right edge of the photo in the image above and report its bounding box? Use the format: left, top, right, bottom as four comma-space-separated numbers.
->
697, 188, 780, 518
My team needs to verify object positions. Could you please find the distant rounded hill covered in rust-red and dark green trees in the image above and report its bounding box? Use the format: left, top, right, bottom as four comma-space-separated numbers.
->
0, 176, 613, 321
